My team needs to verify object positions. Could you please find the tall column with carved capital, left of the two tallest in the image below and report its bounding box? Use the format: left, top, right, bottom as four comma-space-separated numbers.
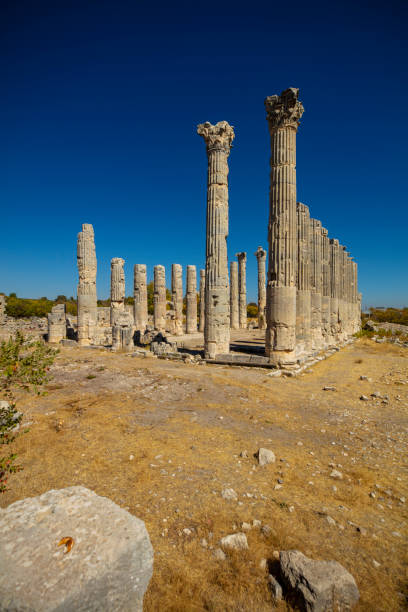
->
197, 121, 234, 358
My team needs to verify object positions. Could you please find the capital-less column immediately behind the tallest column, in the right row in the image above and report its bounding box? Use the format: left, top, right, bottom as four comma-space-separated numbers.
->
296, 202, 311, 353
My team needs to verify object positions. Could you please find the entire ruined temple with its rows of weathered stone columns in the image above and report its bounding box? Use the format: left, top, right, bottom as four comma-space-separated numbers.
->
47, 88, 361, 368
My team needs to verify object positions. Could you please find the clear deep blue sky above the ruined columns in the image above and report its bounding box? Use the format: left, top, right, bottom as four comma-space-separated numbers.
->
0, 0, 408, 306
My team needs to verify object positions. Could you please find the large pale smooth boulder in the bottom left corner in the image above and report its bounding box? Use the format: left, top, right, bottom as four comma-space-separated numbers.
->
0, 487, 153, 612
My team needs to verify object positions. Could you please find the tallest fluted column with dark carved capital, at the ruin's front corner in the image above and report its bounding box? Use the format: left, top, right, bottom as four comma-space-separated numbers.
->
265, 88, 303, 365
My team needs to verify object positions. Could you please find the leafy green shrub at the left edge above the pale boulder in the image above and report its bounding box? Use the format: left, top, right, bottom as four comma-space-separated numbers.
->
0, 331, 59, 493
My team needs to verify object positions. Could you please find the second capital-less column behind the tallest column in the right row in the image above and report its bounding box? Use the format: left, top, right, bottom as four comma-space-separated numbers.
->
310, 219, 323, 350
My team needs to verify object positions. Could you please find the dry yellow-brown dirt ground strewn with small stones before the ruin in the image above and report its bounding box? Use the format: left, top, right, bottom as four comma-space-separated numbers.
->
0, 339, 408, 611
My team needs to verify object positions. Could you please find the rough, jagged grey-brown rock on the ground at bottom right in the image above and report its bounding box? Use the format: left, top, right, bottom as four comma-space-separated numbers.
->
280, 550, 360, 612
